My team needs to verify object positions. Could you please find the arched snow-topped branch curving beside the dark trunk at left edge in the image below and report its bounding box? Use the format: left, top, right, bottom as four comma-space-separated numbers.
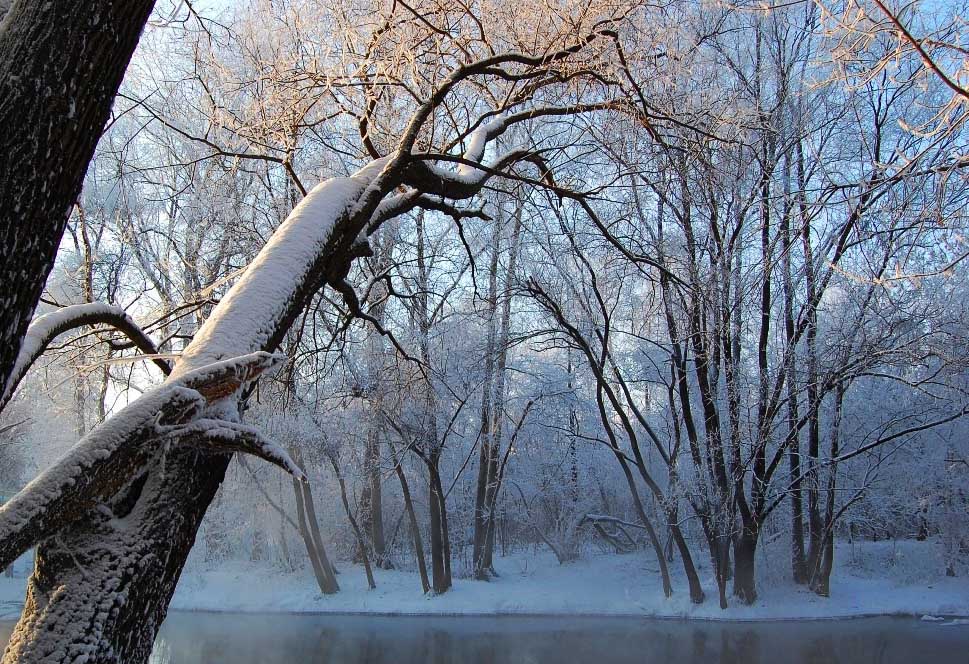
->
0, 302, 171, 410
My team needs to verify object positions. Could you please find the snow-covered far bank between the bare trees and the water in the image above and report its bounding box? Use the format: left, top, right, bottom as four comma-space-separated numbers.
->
0, 542, 969, 620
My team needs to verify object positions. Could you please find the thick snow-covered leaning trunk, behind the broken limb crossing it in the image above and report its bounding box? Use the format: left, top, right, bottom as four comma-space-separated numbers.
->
3, 160, 398, 664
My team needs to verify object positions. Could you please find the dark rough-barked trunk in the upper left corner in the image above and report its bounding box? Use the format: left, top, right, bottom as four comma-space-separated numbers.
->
0, 0, 154, 394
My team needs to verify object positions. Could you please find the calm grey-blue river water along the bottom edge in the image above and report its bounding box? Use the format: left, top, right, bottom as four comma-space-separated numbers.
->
0, 613, 969, 664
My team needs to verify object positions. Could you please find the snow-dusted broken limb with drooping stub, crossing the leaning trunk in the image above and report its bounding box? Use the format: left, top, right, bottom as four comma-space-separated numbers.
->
0, 352, 284, 568
